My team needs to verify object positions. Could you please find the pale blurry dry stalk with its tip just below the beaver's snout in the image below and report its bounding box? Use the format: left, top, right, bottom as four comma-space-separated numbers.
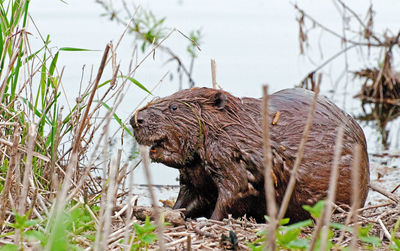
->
140, 146, 166, 250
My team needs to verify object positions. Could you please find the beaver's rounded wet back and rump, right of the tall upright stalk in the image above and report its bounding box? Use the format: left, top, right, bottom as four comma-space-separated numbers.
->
269, 88, 369, 219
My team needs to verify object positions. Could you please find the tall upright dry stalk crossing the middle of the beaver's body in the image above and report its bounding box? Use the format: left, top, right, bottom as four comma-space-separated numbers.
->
262, 85, 278, 250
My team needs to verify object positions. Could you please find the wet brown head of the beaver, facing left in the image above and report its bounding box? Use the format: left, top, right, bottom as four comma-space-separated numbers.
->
130, 88, 235, 168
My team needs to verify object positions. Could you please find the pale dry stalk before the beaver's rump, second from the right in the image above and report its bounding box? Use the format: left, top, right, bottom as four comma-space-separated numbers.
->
315, 127, 344, 250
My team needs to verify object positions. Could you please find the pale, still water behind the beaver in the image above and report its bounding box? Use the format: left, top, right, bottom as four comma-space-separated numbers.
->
31, 0, 400, 196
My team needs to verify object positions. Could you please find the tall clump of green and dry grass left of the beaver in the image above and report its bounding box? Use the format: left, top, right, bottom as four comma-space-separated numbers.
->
0, 0, 159, 250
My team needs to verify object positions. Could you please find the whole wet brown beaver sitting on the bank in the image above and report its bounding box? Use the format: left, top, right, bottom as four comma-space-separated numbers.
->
130, 88, 369, 221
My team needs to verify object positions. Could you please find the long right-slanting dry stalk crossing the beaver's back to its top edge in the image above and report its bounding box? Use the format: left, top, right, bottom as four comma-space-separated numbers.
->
277, 82, 320, 222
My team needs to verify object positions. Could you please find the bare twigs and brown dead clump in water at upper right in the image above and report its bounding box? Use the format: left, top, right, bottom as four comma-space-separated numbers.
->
294, 0, 400, 147
